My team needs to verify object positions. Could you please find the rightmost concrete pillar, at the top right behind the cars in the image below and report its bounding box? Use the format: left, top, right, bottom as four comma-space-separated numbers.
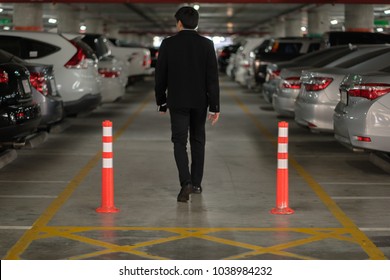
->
344, 4, 374, 31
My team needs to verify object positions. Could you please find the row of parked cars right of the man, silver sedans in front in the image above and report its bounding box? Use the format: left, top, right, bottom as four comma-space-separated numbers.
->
218, 33, 390, 158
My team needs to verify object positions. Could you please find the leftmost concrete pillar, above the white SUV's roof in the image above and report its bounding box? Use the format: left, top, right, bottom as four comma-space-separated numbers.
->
13, 3, 43, 31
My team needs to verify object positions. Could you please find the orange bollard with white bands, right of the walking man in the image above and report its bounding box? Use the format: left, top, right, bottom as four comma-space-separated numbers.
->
270, 122, 294, 215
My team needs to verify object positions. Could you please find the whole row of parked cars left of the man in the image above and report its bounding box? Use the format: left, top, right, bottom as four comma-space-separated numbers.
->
0, 31, 153, 152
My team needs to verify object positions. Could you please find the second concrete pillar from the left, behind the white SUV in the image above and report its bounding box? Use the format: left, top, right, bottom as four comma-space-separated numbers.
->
56, 3, 80, 33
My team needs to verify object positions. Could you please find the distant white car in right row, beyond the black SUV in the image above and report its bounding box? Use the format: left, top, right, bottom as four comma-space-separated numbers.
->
230, 37, 264, 85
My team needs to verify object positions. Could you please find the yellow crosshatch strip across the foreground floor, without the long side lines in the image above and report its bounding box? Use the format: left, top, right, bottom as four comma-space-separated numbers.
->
13, 227, 370, 260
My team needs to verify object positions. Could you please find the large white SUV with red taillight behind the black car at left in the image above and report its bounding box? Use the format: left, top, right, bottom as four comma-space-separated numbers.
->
0, 31, 101, 116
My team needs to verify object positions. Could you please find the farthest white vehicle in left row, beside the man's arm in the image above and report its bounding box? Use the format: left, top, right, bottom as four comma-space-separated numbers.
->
108, 39, 154, 84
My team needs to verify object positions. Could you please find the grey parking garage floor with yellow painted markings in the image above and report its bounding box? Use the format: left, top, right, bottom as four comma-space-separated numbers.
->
0, 76, 390, 260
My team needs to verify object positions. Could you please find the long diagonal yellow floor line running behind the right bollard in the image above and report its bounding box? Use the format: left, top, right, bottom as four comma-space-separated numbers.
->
228, 91, 387, 260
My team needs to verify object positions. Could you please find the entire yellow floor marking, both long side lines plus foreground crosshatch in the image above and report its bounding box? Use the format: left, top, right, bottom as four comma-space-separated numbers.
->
5, 90, 386, 260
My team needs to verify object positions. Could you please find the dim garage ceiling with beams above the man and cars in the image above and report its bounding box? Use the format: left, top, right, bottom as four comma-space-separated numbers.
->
0, 0, 390, 35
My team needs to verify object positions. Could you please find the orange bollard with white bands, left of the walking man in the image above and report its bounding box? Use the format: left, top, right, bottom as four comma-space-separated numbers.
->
96, 121, 119, 213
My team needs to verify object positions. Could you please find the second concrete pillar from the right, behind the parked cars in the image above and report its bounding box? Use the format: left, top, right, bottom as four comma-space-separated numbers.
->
307, 7, 329, 37
